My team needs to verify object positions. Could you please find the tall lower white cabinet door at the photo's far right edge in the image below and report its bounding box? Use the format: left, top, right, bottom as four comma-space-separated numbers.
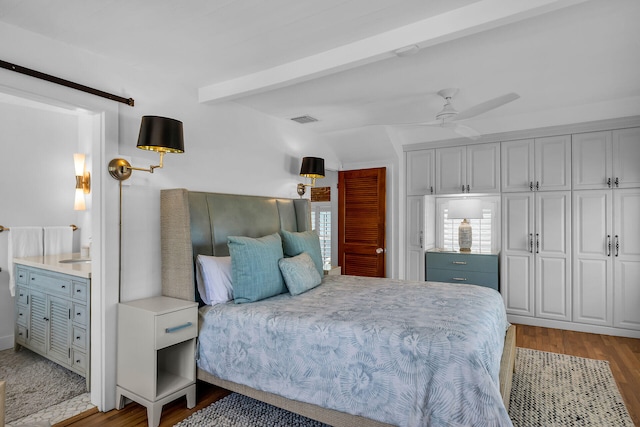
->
613, 189, 640, 330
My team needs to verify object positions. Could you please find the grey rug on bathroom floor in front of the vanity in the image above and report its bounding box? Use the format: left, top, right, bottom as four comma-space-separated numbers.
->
0, 348, 87, 423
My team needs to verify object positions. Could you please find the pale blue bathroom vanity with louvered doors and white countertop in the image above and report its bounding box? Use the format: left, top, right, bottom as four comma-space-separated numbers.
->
14, 254, 91, 389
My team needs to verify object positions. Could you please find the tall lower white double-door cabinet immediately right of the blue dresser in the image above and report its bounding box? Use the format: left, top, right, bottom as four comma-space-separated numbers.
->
501, 191, 571, 321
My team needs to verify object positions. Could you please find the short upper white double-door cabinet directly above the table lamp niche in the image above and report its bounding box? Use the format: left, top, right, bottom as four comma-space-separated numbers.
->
435, 142, 500, 194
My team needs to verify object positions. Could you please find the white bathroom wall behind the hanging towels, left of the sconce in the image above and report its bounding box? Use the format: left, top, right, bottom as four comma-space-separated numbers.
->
0, 101, 91, 350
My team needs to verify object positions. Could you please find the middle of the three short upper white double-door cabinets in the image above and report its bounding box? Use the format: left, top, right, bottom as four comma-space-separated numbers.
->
501, 135, 571, 193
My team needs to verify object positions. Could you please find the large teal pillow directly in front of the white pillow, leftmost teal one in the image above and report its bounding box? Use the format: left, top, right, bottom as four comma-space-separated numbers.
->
227, 233, 287, 304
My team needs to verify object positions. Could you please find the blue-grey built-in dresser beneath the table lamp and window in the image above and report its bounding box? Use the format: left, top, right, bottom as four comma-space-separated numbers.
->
426, 249, 499, 291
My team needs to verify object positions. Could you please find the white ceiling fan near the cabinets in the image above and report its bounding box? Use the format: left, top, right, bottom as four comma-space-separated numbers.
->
404, 88, 520, 139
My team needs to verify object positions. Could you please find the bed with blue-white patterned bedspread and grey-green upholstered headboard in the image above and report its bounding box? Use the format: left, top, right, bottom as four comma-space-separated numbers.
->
161, 189, 515, 427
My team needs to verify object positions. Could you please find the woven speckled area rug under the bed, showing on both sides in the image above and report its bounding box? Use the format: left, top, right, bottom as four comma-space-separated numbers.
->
171, 348, 634, 427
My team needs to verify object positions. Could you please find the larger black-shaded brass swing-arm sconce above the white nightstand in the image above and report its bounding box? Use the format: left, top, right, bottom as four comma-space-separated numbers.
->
109, 116, 184, 181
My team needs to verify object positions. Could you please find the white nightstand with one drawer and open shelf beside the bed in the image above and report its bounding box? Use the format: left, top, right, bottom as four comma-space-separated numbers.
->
116, 297, 198, 427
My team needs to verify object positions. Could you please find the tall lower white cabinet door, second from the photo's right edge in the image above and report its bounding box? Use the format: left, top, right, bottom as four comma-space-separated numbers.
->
572, 190, 613, 326
